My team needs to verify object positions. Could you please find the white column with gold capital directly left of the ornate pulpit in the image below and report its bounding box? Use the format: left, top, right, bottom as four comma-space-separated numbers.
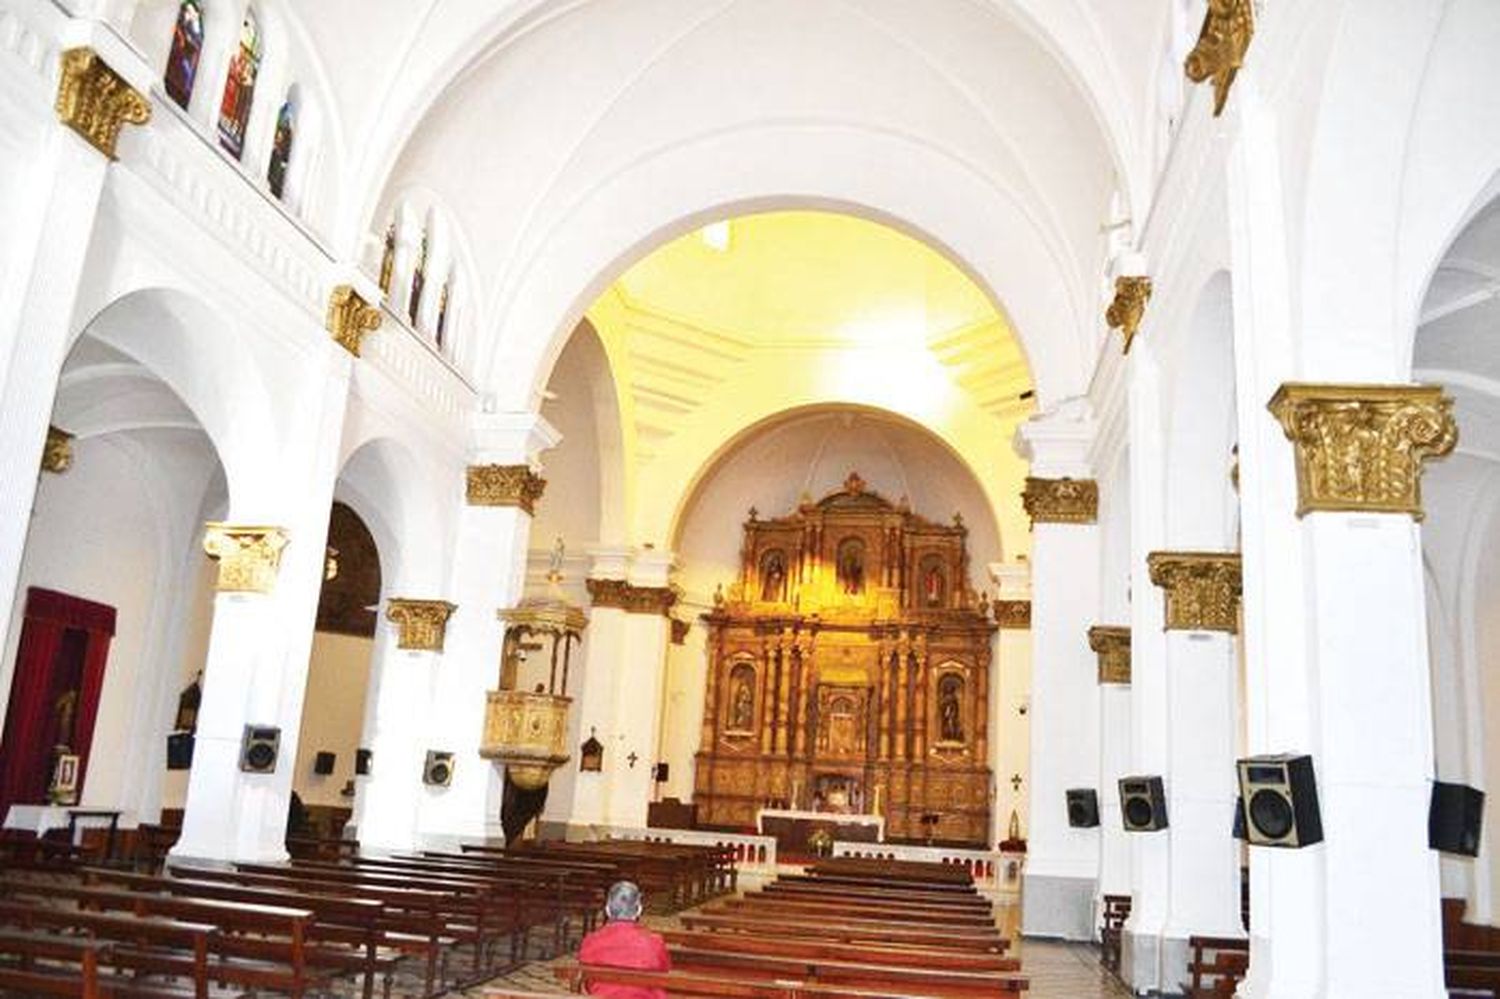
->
420, 413, 561, 843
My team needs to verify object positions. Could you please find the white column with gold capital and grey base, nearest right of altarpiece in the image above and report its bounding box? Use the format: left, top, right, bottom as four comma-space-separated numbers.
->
1019, 407, 1100, 941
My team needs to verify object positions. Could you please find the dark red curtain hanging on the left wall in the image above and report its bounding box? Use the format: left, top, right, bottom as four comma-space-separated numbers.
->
0, 587, 116, 816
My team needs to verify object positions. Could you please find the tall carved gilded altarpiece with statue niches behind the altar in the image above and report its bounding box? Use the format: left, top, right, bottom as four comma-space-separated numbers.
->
695, 476, 996, 843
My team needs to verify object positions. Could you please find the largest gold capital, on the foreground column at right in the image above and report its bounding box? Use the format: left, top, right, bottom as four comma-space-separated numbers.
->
1271, 383, 1458, 521
